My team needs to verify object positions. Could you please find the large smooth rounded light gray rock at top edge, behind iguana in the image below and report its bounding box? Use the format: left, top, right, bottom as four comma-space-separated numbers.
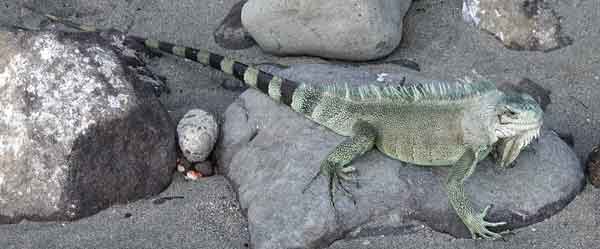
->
242, 0, 411, 60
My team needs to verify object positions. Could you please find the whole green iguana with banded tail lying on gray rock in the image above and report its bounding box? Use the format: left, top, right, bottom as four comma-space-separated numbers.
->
46, 15, 543, 239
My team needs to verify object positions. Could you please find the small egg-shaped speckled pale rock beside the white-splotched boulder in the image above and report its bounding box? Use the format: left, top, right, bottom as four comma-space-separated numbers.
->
177, 109, 219, 163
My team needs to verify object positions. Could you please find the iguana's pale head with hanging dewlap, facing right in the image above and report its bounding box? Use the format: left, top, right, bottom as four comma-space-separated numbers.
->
496, 93, 543, 167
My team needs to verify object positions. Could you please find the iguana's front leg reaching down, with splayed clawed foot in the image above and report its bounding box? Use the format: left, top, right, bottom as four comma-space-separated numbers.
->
446, 149, 506, 239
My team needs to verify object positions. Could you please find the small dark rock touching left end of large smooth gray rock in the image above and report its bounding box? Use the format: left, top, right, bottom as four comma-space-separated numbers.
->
213, 0, 255, 49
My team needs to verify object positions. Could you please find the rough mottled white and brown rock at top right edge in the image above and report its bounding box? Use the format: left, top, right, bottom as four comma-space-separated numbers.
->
463, 0, 572, 51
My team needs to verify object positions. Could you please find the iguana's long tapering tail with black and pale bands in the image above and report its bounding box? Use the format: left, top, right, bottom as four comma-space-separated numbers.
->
40, 13, 300, 108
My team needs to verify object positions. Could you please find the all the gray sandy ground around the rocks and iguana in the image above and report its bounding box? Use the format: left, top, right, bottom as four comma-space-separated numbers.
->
0, 0, 600, 249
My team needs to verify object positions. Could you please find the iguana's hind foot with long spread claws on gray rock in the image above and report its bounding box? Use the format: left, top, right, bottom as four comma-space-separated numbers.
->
302, 161, 358, 208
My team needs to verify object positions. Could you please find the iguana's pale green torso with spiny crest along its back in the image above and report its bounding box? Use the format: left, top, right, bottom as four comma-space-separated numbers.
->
302, 81, 502, 165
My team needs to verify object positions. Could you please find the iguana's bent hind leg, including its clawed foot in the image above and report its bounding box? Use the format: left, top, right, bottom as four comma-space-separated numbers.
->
302, 120, 377, 208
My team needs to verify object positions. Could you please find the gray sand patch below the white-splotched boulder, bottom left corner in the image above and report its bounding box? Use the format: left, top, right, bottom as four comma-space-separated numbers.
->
0, 176, 248, 249
